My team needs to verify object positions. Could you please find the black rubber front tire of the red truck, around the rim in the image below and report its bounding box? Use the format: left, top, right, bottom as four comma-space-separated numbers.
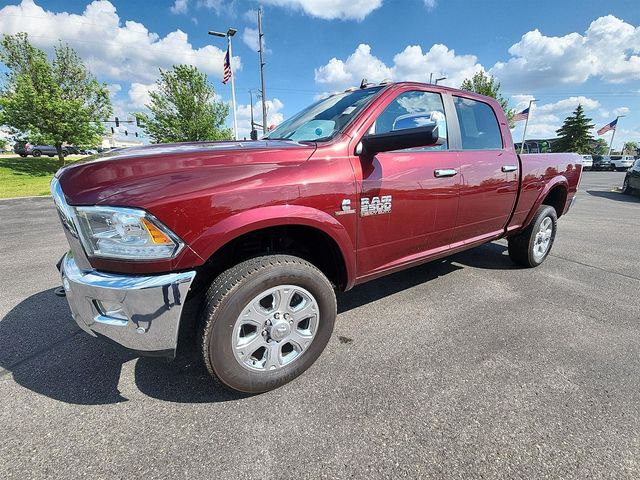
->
205, 263, 336, 393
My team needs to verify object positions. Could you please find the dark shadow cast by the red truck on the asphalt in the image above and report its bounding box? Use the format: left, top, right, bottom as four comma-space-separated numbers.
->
0, 244, 515, 405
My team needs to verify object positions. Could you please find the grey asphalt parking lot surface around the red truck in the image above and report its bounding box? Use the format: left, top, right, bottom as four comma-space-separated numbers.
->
0, 172, 640, 479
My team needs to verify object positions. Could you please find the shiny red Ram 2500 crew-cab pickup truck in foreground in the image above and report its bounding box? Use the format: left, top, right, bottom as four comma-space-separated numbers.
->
52, 83, 582, 393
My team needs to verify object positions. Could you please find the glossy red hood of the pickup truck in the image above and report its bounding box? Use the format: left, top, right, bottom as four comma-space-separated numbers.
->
56, 140, 316, 207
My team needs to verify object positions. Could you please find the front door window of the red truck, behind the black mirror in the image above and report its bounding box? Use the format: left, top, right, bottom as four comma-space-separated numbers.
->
370, 90, 447, 151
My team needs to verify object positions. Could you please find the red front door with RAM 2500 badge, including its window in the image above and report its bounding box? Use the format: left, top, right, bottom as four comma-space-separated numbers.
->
352, 90, 460, 277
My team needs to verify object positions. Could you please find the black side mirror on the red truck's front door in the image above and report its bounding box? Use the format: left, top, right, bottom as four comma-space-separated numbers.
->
356, 125, 439, 155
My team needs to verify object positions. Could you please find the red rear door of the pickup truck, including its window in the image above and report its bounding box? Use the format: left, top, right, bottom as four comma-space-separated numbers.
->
453, 96, 519, 247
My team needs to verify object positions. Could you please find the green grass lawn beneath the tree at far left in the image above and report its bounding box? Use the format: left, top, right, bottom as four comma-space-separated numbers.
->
0, 155, 83, 198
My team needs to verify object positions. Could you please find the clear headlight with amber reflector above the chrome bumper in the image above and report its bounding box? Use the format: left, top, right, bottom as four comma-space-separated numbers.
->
73, 207, 183, 260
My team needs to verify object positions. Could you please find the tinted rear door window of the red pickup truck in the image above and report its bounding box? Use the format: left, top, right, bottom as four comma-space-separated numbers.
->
453, 96, 502, 150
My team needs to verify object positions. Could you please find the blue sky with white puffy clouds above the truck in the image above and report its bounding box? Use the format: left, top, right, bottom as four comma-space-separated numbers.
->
0, 0, 640, 148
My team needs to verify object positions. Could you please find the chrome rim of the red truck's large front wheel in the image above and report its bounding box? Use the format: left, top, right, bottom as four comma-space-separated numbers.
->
231, 285, 320, 372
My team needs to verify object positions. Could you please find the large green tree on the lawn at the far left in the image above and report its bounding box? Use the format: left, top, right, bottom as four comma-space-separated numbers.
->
0, 33, 111, 165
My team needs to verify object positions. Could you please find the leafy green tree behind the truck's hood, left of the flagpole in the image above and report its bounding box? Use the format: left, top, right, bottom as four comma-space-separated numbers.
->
136, 65, 231, 143
